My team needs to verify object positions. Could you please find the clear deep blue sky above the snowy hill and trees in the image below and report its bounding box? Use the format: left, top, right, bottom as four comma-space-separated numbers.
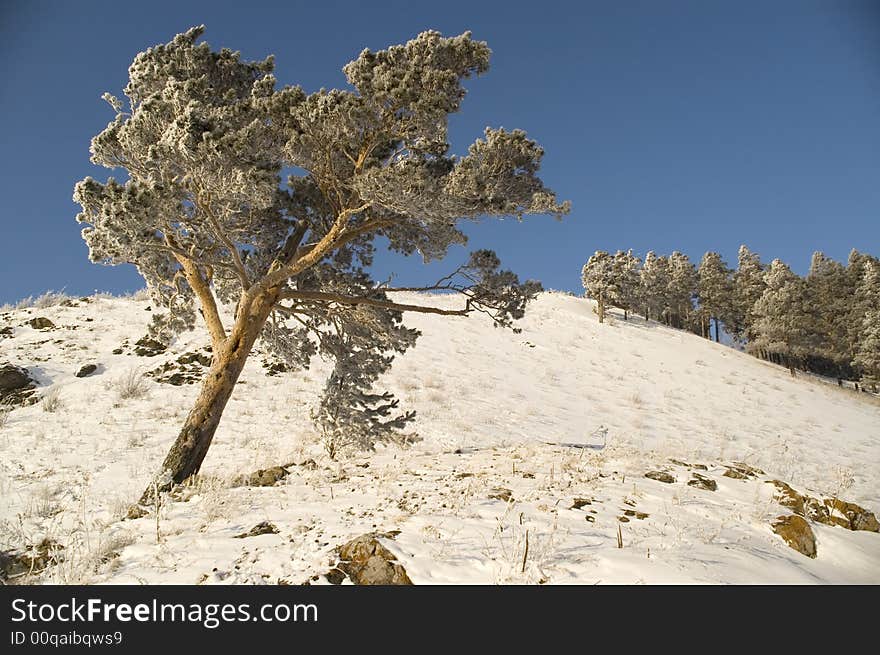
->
0, 0, 880, 302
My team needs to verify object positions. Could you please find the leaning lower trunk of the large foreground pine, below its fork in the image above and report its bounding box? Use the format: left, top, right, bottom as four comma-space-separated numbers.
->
140, 296, 274, 505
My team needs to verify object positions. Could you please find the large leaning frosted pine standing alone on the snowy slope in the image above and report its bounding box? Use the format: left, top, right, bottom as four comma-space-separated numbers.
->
74, 26, 569, 501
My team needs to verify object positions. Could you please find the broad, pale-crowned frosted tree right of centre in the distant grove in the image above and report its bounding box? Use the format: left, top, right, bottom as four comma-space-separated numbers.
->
748, 259, 816, 375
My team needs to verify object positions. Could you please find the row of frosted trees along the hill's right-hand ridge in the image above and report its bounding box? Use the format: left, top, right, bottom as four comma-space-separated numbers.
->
581, 246, 880, 391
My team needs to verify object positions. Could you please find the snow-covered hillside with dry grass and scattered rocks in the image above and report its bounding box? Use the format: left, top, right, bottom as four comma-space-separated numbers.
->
0, 293, 880, 584
